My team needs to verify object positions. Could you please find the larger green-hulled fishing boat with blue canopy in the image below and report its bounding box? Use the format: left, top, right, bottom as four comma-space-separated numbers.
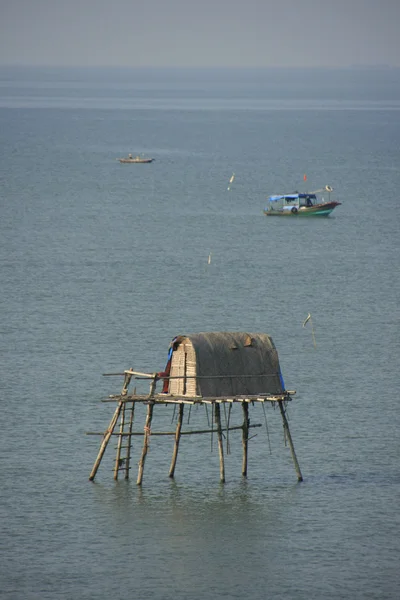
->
264, 185, 341, 217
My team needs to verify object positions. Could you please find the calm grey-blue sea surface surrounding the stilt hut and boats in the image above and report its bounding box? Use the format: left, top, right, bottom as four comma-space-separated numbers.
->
0, 68, 400, 600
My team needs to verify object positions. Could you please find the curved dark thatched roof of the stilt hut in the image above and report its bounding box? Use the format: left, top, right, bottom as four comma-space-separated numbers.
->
176, 332, 284, 397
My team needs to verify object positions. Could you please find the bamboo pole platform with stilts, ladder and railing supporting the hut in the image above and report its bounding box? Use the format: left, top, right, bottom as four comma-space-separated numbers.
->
87, 369, 303, 485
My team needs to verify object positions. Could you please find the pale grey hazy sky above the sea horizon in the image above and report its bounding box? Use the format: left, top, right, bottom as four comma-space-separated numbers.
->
0, 0, 400, 66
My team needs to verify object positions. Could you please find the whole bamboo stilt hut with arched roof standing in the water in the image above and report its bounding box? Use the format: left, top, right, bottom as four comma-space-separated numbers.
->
89, 332, 302, 485
